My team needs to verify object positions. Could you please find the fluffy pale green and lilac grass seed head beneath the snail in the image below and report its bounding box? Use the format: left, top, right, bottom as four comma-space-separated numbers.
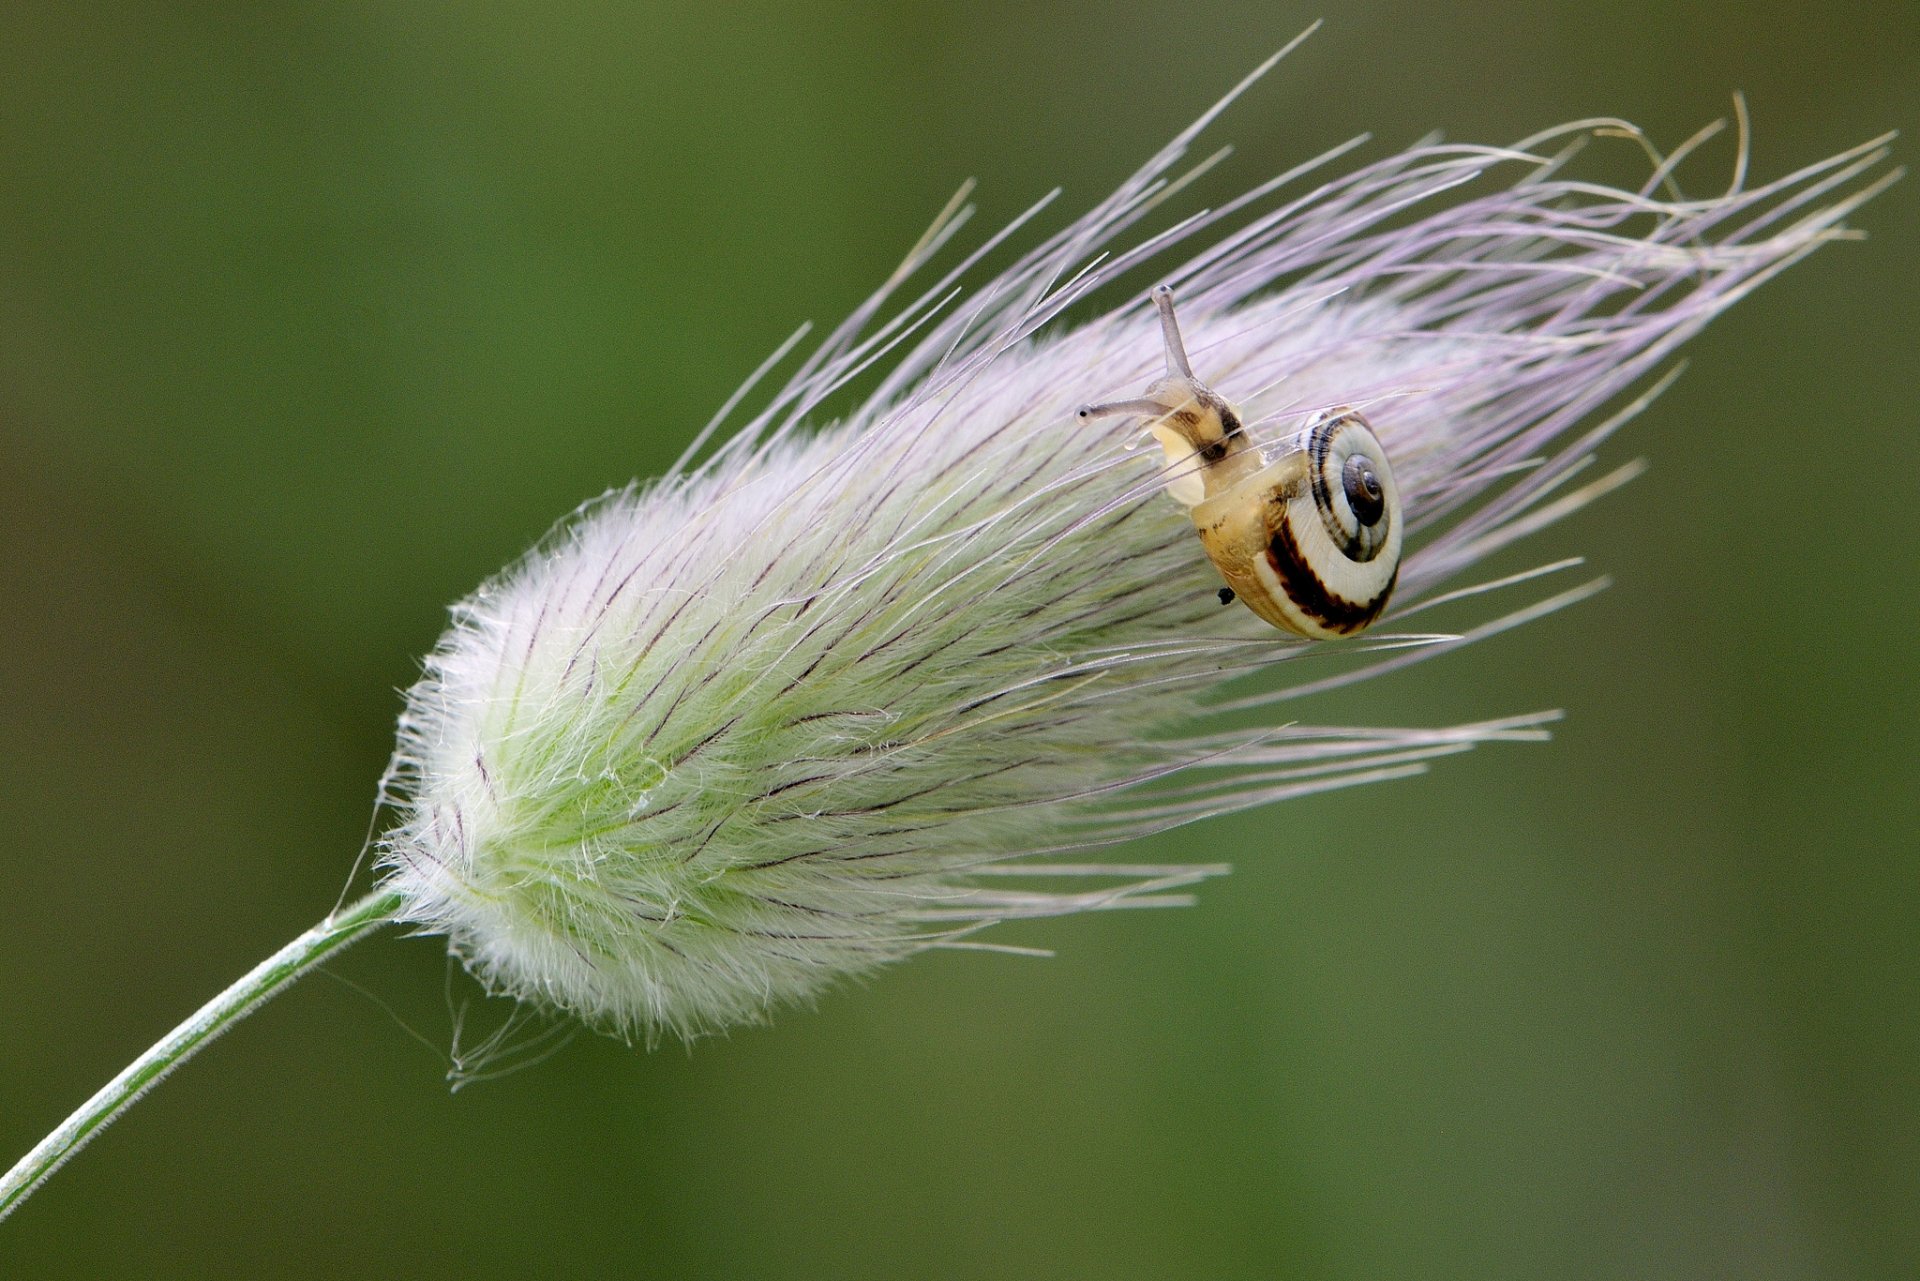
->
370, 62, 1891, 1037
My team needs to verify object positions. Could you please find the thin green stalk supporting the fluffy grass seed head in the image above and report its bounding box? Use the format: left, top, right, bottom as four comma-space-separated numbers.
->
0, 891, 401, 1220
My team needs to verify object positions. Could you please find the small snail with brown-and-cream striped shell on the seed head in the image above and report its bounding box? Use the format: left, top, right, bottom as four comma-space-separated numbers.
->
1079, 284, 1402, 640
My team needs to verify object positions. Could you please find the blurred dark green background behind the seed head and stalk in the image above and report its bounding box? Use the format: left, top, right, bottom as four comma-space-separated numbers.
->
0, 0, 1920, 1281
